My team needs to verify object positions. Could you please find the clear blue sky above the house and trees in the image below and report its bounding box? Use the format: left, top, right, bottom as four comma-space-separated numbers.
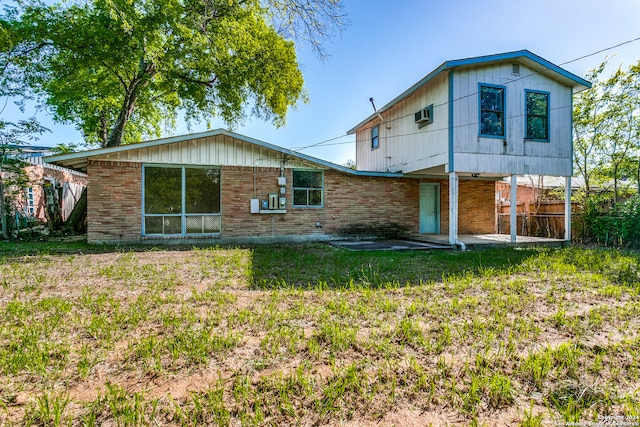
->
2, 0, 640, 164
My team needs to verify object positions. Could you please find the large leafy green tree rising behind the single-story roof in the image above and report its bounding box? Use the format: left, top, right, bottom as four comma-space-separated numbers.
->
0, 0, 343, 147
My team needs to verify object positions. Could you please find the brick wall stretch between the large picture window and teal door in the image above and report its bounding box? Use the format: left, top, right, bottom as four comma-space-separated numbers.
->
222, 167, 419, 237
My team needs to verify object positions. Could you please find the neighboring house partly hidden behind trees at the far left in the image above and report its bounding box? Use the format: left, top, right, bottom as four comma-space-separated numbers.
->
2, 145, 87, 226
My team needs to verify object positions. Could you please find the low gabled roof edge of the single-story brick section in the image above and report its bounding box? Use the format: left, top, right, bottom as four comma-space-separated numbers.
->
44, 129, 402, 177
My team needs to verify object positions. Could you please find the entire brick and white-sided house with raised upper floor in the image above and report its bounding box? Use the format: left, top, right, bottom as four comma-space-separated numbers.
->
47, 51, 589, 244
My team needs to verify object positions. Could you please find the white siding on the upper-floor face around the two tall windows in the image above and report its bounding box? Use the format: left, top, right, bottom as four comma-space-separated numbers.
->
454, 63, 572, 176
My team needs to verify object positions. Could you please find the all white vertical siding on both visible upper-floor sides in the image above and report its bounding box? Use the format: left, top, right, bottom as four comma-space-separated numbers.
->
356, 61, 572, 176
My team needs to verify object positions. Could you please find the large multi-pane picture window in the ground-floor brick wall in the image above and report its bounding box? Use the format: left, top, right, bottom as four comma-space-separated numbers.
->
142, 166, 221, 236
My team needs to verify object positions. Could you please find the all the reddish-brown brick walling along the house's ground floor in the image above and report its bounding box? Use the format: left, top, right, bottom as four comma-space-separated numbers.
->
88, 161, 495, 242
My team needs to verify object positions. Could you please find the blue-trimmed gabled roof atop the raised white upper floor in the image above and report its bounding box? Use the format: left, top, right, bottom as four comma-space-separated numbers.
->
347, 50, 591, 135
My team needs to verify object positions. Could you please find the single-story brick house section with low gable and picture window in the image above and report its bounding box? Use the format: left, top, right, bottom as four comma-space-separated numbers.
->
47, 130, 495, 243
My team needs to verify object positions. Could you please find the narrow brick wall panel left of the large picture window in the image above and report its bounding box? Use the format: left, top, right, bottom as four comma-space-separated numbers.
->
87, 160, 142, 243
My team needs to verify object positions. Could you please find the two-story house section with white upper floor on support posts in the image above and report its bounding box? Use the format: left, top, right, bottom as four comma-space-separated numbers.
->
348, 50, 591, 244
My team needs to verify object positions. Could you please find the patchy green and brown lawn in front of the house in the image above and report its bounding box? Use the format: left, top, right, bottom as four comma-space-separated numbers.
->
0, 243, 640, 427
